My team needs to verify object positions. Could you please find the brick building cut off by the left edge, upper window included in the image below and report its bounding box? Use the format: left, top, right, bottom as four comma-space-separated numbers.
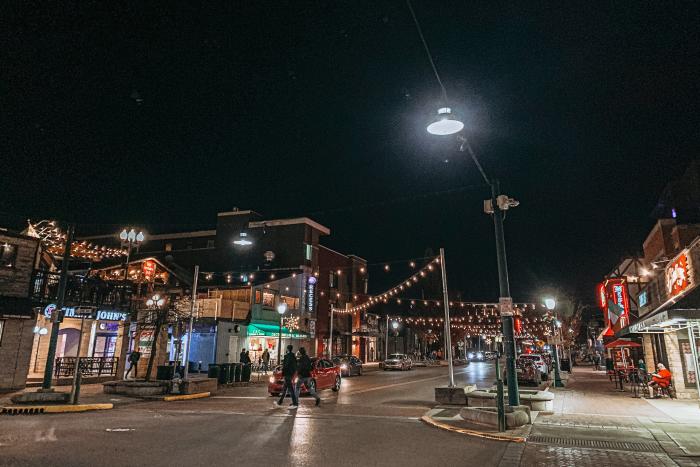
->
0, 230, 39, 392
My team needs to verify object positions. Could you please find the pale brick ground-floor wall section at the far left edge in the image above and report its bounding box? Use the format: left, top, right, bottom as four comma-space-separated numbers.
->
0, 318, 34, 392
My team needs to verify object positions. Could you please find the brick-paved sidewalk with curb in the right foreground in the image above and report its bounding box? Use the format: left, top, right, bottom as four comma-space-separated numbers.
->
429, 366, 700, 467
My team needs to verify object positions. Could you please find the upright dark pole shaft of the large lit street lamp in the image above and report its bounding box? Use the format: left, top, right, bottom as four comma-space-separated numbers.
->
491, 180, 520, 406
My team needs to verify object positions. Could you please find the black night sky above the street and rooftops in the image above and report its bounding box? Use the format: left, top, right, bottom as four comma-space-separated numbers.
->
0, 0, 700, 300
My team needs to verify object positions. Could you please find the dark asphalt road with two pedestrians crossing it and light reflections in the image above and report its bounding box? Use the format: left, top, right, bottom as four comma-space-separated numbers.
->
0, 363, 506, 466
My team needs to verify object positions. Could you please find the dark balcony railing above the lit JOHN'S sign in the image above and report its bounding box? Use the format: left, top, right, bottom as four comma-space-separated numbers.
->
30, 270, 134, 309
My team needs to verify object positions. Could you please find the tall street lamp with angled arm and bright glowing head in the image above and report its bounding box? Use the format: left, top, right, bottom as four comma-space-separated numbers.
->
427, 119, 520, 406
